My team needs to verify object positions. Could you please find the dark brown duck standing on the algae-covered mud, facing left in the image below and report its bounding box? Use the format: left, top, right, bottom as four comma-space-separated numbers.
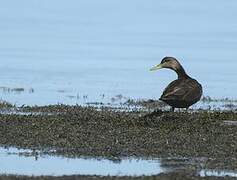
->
150, 57, 203, 112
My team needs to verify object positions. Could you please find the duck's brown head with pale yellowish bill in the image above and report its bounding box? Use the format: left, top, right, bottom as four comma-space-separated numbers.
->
150, 57, 182, 72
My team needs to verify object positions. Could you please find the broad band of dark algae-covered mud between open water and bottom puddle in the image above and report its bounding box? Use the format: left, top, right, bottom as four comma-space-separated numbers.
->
0, 105, 237, 159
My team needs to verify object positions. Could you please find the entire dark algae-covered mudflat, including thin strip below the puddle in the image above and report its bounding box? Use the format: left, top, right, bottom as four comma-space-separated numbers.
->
0, 101, 237, 179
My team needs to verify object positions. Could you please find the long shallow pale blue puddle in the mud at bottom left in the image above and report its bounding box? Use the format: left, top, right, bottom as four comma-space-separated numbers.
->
0, 148, 165, 176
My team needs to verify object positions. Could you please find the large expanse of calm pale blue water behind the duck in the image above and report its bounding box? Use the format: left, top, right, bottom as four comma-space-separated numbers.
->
0, 0, 237, 105
